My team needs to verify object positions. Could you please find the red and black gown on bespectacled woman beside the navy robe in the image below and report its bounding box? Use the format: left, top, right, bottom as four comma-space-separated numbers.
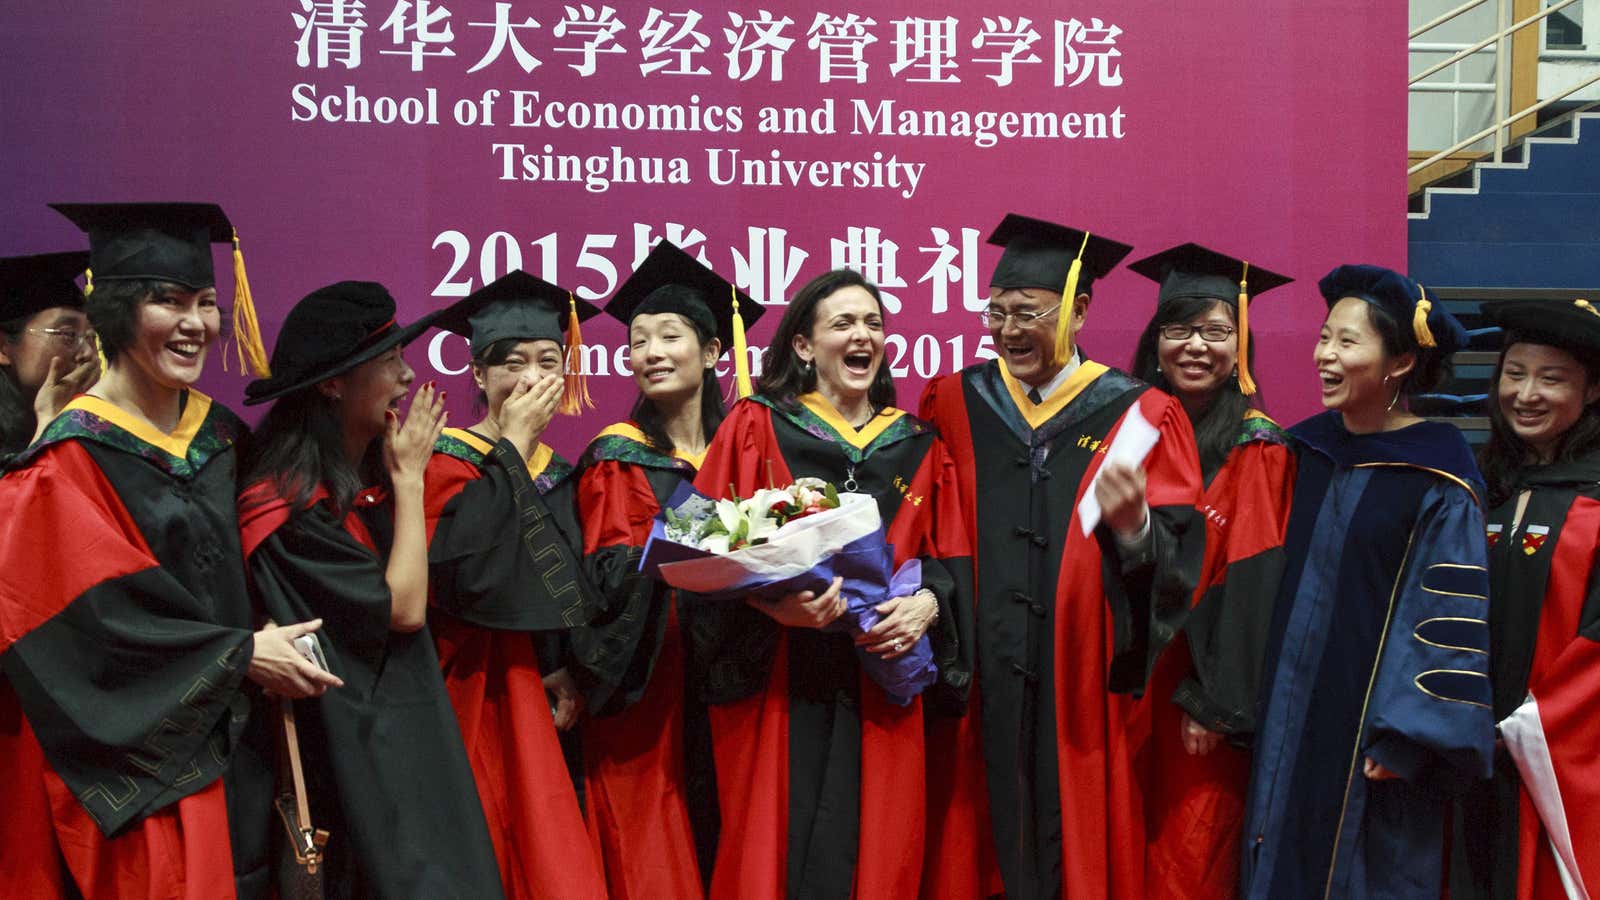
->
1146, 410, 1294, 900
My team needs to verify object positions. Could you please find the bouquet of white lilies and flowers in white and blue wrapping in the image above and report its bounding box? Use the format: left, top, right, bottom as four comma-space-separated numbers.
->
640, 477, 936, 706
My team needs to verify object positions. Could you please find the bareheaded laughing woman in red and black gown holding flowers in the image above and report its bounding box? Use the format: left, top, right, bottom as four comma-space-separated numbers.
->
691, 269, 971, 898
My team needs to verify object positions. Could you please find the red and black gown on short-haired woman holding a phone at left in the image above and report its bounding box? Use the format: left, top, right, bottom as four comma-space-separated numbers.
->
0, 391, 270, 898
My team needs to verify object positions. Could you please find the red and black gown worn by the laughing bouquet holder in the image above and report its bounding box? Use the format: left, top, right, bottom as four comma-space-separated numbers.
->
690, 394, 971, 900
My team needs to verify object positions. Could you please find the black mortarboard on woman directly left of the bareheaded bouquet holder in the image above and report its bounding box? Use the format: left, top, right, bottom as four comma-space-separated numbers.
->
605, 240, 766, 351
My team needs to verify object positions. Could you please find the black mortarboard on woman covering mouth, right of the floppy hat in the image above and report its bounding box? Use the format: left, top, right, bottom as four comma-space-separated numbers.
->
434, 269, 600, 357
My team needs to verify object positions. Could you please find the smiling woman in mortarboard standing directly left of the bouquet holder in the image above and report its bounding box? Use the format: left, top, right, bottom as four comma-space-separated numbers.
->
573, 240, 762, 897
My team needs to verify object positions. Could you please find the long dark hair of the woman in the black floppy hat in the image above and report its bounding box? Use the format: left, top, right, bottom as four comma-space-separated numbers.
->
240, 384, 387, 516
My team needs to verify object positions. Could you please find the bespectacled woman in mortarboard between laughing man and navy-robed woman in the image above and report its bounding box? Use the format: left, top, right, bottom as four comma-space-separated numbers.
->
1128, 243, 1294, 900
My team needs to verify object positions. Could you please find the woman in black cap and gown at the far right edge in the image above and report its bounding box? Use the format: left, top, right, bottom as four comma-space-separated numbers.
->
1450, 293, 1600, 900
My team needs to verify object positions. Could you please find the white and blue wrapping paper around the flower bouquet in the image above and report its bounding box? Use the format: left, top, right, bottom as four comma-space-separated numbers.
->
638, 484, 938, 706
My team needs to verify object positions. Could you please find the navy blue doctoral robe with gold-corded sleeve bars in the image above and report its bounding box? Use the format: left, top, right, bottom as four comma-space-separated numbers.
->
1242, 412, 1494, 898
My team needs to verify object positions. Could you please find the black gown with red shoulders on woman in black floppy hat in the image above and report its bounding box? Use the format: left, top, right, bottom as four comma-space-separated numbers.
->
240, 482, 502, 900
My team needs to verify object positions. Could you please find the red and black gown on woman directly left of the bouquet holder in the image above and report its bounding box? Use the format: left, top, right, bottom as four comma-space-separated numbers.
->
573, 423, 715, 900
